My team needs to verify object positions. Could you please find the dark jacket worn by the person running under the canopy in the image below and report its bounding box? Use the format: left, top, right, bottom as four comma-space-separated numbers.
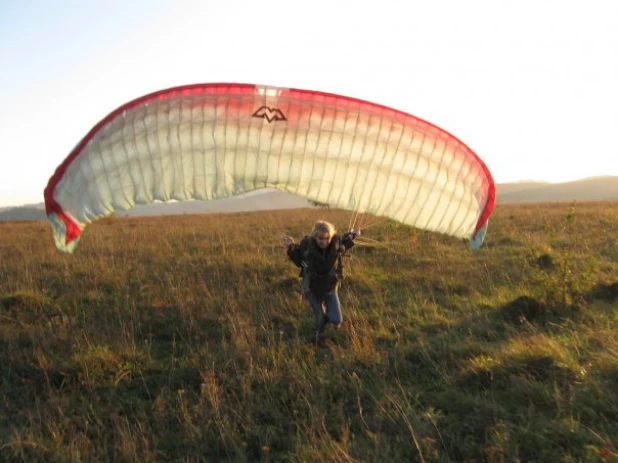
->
288, 233, 355, 299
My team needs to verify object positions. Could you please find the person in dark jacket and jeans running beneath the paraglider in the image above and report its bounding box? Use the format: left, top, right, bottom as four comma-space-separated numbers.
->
283, 220, 360, 341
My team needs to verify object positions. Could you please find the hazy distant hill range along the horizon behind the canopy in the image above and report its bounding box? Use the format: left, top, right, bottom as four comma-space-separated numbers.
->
0, 177, 618, 221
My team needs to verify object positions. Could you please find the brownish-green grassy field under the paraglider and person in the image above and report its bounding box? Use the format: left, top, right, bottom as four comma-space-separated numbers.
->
0, 203, 618, 463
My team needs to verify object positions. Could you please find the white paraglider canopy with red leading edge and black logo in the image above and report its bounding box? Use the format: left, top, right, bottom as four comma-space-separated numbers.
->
44, 84, 495, 252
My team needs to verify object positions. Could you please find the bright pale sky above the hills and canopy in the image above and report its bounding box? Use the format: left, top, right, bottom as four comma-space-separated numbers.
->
0, 0, 618, 207
